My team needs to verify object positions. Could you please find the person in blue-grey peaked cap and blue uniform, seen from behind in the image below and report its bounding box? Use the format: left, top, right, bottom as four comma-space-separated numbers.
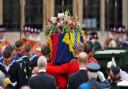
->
79, 63, 106, 89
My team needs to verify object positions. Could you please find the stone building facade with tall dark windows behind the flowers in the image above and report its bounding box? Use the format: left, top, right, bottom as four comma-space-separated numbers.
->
0, 0, 128, 44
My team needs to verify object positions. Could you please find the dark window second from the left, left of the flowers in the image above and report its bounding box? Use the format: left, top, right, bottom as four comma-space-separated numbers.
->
25, 0, 43, 25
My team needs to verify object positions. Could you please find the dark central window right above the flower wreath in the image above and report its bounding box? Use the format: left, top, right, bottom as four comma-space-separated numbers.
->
55, 0, 73, 16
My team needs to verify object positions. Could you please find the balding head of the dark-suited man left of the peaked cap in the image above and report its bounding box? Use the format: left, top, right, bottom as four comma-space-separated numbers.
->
78, 52, 88, 68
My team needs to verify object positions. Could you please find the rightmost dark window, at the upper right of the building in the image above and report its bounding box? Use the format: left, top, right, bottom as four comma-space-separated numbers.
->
105, 0, 122, 30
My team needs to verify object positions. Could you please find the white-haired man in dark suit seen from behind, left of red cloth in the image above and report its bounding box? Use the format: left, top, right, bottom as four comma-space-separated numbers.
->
28, 56, 56, 89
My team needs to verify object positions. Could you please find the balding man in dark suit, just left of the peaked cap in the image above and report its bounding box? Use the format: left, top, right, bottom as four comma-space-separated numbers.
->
68, 52, 88, 89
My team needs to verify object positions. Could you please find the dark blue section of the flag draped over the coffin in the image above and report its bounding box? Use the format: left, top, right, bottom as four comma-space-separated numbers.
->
55, 34, 74, 65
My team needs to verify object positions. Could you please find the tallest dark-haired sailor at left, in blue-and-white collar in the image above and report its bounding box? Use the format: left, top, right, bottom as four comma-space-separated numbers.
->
15, 40, 32, 87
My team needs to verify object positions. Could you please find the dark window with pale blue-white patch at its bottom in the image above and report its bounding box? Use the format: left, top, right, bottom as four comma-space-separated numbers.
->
83, 0, 100, 30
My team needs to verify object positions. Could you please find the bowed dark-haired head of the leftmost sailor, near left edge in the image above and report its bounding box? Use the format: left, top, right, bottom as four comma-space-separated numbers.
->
3, 48, 12, 65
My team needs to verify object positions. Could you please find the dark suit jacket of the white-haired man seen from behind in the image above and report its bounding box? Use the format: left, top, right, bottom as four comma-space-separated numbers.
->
28, 72, 56, 89
